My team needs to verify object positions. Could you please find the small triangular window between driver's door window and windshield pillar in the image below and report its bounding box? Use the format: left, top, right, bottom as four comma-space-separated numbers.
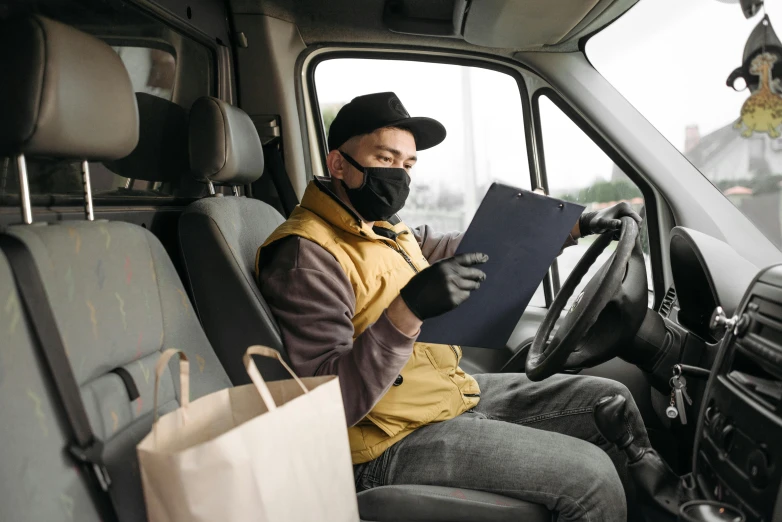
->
538, 95, 654, 306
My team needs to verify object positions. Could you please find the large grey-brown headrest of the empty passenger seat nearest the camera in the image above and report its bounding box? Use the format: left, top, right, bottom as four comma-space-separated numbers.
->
0, 15, 138, 160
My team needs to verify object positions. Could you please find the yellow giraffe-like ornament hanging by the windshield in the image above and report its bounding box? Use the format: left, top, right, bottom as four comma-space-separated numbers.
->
734, 53, 782, 138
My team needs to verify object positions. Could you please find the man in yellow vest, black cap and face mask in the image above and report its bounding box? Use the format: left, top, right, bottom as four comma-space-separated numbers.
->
256, 93, 648, 521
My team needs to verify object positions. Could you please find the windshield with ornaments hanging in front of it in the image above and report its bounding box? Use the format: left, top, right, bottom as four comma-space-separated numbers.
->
586, 0, 782, 249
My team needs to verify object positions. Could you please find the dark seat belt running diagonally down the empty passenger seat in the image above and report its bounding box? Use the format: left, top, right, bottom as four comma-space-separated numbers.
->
0, 234, 117, 522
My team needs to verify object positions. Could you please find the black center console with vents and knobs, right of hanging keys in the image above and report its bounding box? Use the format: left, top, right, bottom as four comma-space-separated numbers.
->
693, 266, 782, 522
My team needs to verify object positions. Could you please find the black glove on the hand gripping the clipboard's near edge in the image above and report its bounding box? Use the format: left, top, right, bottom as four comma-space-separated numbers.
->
399, 252, 489, 321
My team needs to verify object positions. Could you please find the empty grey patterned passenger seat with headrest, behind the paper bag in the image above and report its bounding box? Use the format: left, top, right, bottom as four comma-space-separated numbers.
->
0, 16, 230, 522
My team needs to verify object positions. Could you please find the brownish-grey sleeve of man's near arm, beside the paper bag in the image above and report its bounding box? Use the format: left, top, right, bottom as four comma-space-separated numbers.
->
258, 236, 415, 426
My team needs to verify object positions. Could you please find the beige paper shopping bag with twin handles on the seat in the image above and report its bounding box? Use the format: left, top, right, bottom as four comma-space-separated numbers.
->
137, 346, 358, 522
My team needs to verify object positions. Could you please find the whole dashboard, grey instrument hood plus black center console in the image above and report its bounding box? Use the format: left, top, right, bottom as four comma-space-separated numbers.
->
661, 228, 782, 522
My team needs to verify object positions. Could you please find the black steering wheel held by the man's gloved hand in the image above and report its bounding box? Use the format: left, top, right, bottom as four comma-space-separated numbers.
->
526, 217, 647, 381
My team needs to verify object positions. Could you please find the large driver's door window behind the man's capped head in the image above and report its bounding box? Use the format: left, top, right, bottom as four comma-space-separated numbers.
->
315, 58, 546, 306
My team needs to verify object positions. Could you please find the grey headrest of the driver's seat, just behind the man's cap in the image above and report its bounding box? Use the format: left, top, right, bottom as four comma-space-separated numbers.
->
188, 96, 263, 185
